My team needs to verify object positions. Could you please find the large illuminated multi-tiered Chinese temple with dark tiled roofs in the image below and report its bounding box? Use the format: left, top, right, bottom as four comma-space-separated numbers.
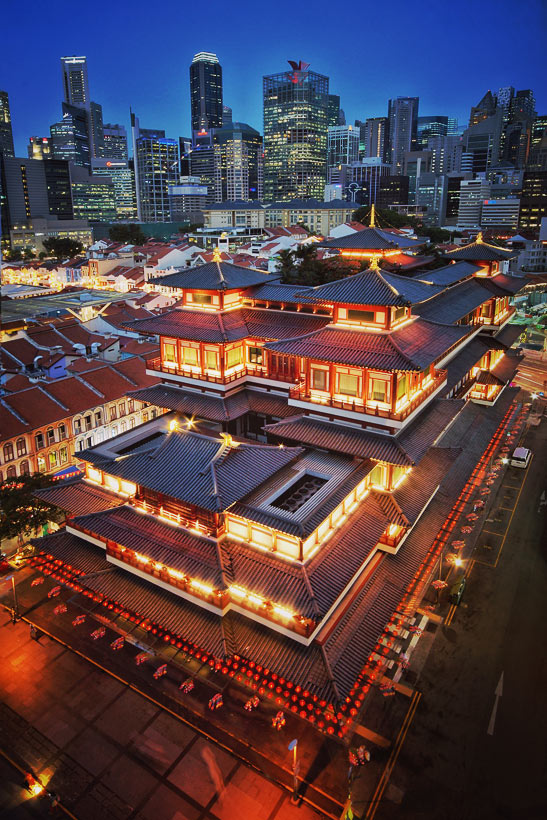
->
30, 235, 525, 724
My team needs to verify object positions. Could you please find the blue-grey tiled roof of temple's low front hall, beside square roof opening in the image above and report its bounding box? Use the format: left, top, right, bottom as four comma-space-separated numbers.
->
80, 431, 302, 511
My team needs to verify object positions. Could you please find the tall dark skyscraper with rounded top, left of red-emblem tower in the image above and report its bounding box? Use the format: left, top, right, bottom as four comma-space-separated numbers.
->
190, 51, 223, 131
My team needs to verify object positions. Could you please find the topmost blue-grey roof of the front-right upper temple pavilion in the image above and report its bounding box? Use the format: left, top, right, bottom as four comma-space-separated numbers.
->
297, 267, 441, 307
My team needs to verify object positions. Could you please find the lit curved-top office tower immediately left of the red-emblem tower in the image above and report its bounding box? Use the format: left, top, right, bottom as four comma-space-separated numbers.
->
213, 122, 263, 202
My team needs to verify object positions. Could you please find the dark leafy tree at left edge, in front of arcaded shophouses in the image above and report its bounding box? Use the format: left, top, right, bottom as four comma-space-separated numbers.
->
0, 473, 62, 540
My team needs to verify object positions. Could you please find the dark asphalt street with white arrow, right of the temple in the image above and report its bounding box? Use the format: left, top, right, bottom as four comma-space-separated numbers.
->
376, 406, 547, 820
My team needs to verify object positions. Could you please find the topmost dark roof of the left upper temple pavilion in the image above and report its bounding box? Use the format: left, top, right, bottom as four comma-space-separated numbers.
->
149, 262, 273, 290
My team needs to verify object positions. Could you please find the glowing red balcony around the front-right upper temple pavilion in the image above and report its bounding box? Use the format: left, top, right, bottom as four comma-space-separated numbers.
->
289, 370, 447, 424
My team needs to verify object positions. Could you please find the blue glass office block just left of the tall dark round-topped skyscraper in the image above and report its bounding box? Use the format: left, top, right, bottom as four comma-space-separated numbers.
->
131, 112, 179, 222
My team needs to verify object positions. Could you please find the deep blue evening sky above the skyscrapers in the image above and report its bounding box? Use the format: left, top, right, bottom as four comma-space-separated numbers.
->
0, 0, 547, 156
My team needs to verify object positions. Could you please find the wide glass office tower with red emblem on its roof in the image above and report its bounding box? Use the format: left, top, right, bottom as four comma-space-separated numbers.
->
263, 61, 329, 202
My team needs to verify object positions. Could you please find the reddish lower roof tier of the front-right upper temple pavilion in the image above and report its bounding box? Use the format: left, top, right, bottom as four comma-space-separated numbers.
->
265, 318, 469, 371
